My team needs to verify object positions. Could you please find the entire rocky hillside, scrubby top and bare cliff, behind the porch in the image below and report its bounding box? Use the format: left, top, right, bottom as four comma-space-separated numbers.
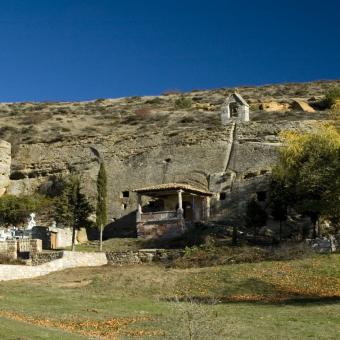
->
0, 81, 340, 232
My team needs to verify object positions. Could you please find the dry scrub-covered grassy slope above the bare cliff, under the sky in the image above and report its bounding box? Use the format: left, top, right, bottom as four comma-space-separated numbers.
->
0, 81, 340, 143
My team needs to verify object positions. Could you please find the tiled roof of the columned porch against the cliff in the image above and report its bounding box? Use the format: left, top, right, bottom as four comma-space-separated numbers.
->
133, 183, 213, 196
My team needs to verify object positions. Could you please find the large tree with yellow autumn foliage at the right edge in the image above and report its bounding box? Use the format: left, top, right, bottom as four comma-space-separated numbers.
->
273, 125, 340, 237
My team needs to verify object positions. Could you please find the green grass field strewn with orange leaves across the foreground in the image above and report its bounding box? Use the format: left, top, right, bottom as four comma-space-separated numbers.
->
0, 254, 340, 339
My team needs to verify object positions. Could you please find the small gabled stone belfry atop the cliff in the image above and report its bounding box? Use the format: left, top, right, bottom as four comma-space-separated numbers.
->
221, 92, 249, 125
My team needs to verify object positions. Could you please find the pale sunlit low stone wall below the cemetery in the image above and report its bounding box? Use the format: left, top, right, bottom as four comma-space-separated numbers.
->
0, 251, 108, 281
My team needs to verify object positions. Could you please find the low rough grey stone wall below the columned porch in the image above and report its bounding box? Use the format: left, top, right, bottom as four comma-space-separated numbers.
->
106, 249, 184, 265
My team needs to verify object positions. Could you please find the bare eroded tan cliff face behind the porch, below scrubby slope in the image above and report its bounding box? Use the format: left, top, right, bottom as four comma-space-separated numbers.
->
3, 117, 316, 228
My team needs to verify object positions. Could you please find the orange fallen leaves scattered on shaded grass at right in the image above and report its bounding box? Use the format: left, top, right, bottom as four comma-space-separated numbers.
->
169, 258, 340, 303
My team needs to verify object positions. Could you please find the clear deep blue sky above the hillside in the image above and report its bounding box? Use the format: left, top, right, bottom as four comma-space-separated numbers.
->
0, 0, 340, 101
